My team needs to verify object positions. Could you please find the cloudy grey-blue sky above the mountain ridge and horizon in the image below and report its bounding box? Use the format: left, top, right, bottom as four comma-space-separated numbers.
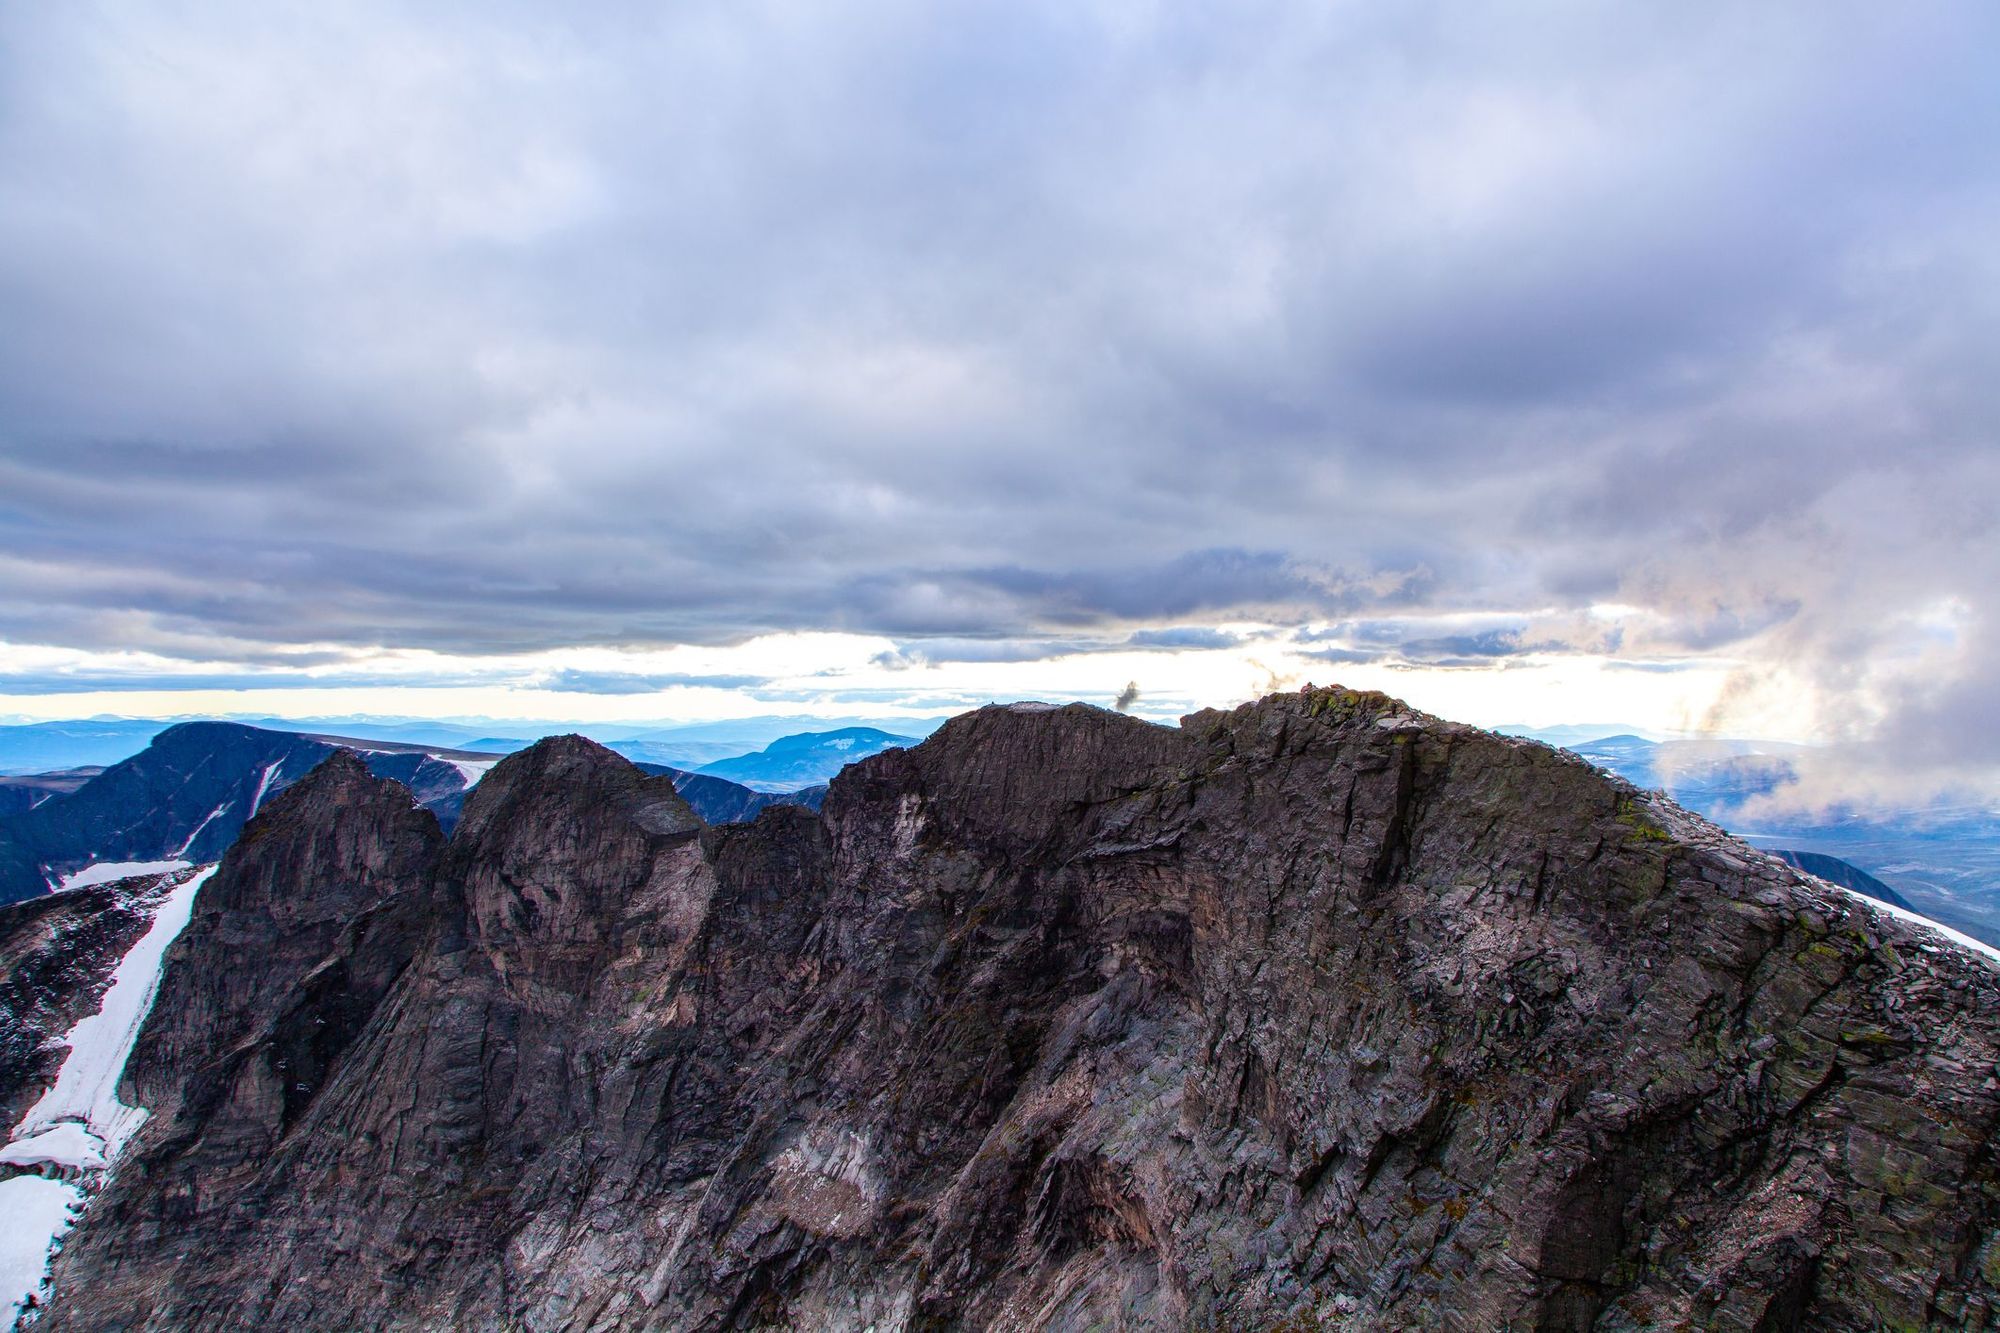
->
0, 0, 2000, 789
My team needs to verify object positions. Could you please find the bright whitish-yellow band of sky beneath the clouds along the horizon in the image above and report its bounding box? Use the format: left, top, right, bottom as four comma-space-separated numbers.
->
0, 624, 1784, 737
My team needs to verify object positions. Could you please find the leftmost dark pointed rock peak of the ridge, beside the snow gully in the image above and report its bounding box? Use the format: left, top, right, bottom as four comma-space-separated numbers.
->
43, 751, 444, 1301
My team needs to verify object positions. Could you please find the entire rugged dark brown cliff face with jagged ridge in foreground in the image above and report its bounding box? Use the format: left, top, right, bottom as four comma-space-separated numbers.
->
27, 691, 2000, 1329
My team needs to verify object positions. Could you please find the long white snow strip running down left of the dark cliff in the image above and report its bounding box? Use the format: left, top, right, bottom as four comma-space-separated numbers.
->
0, 860, 216, 1325
